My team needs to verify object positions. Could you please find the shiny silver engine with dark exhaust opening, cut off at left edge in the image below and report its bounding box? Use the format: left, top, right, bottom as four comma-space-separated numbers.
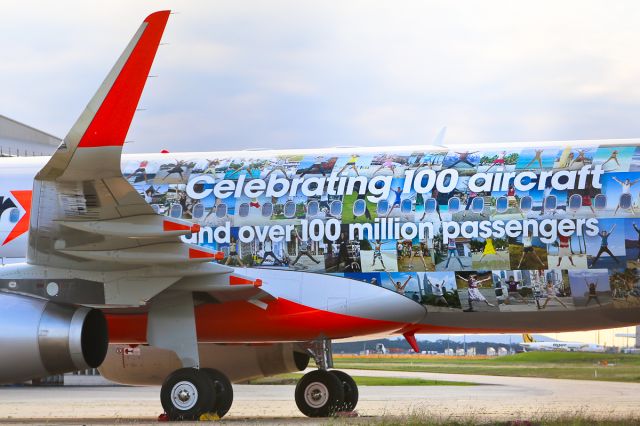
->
0, 293, 108, 383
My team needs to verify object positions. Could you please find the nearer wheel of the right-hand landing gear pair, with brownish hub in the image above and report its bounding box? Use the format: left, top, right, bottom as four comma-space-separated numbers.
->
295, 370, 344, 417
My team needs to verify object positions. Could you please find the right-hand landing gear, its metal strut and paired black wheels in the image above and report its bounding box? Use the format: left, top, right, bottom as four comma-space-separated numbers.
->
295, 339, 358, 417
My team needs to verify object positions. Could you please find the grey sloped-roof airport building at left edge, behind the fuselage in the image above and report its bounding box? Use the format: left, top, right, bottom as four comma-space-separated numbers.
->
0, 115, 61, 157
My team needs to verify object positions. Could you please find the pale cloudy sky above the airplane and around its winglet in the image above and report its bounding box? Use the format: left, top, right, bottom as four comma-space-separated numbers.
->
0, 0, 640, 346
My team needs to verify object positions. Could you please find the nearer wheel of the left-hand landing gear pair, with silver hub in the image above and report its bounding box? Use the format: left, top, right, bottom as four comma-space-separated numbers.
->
160, 368, 216, 420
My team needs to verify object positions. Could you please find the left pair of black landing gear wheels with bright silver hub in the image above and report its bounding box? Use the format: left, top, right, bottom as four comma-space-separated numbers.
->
160, 368, 233, 420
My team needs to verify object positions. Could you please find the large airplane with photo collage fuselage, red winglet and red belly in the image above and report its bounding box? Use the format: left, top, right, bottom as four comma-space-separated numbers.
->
0, 11, 640, 420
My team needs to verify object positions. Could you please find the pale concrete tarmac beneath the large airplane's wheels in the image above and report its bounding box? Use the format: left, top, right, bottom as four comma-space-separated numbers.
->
0, 370, 640, 424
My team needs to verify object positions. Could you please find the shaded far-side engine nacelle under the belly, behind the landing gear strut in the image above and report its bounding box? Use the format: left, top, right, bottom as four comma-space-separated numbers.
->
99, 343, 309, 385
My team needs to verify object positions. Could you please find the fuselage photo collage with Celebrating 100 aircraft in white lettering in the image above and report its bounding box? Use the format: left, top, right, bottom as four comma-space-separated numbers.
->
123, 145, 640, 312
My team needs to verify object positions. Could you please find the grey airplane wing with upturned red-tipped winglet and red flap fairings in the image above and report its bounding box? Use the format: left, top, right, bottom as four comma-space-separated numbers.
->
27, 11, 264, 305
